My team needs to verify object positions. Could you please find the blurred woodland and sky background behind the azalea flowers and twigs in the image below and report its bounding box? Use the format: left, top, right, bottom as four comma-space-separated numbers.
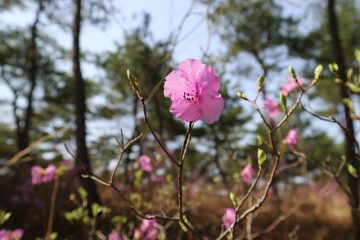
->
0, 0, 360, 239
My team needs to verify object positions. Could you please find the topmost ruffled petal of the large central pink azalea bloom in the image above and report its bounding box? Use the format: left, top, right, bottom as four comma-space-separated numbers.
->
178, 59, 206, 82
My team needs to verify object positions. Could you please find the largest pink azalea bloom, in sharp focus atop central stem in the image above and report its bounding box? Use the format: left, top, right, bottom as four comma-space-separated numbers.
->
164, 59, 224, 124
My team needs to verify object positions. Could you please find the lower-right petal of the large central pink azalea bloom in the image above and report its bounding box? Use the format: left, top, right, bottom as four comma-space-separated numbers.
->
199, 93, 224, 124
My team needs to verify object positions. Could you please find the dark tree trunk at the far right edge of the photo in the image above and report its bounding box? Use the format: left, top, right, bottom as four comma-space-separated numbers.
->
328, 0, 360, 240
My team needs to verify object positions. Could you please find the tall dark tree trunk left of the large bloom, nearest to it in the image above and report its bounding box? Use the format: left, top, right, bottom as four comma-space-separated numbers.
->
72, 0, 100, 206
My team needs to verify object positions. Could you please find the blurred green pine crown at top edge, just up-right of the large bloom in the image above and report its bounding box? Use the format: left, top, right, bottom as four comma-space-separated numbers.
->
210, 0, 295, 75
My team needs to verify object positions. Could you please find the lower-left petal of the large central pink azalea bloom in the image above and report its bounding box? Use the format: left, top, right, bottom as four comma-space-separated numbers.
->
170, 99, 201, 122
